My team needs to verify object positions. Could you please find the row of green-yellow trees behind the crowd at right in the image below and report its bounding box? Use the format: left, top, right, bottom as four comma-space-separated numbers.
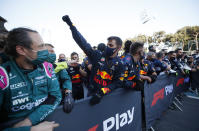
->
127, 26, 199, 50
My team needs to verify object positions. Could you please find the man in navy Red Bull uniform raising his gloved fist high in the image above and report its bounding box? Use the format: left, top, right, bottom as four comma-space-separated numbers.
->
62, 15, 124, 105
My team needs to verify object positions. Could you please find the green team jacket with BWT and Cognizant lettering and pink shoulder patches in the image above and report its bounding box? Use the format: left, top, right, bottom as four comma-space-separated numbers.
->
0, 61, 61, 125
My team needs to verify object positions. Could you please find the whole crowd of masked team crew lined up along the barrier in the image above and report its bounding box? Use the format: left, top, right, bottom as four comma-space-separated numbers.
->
0, 15, 199, 131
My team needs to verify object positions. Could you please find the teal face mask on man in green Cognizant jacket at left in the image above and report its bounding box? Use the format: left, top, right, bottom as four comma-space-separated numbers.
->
31, 50, 49, 65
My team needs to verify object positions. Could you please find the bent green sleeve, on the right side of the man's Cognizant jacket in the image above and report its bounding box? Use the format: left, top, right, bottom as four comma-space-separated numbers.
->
28, 69, 62, 125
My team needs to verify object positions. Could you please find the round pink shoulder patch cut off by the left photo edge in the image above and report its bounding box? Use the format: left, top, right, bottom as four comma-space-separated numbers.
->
0, 67, 9, 90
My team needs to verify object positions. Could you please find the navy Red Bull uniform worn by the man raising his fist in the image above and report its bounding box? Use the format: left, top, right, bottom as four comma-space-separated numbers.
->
65, 25, 123, 98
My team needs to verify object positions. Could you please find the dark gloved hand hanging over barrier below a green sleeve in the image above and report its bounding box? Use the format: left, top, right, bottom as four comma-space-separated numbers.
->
63, 93, 74, 113
